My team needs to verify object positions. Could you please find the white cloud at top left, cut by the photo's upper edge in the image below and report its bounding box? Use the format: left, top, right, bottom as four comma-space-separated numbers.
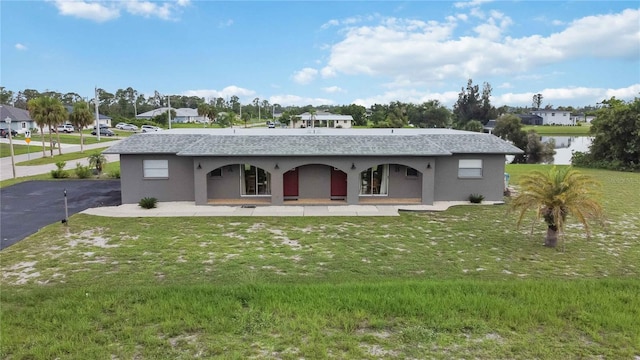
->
54, 0, 190, 22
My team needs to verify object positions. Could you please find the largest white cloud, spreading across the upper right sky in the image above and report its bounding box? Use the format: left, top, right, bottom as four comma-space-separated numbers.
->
321, 9, 640, 86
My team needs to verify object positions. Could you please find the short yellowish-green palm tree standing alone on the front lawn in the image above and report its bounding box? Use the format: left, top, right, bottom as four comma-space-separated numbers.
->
511, 166, 603, 247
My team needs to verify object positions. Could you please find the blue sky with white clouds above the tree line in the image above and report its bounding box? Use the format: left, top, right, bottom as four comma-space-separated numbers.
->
0, 0, 640, 106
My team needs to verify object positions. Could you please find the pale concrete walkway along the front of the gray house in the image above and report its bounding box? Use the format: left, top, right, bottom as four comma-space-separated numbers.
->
82, 201, 503, 217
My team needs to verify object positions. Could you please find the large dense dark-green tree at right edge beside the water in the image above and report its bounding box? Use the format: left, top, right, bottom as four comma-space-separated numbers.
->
589, 97, 640, 170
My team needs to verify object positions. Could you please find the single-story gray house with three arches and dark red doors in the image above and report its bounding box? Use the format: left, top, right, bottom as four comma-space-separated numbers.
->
104, 128, 522, 205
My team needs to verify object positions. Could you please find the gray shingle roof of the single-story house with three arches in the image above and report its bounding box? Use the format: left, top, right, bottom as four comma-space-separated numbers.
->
105, 129, 521, 156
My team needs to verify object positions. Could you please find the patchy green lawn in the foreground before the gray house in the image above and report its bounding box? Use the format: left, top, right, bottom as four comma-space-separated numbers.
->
0, 165, 640, 359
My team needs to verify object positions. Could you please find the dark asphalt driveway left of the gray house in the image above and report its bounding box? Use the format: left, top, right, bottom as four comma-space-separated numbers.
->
0, 180, 121, 249
